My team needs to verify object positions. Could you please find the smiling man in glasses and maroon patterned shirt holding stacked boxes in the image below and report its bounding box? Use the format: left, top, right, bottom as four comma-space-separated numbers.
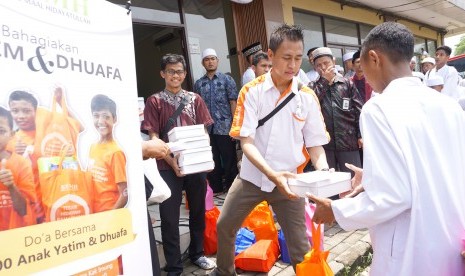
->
142, 54, 215, 276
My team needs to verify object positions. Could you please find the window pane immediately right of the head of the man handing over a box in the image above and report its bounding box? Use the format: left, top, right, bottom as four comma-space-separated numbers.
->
294, 11, 324, 72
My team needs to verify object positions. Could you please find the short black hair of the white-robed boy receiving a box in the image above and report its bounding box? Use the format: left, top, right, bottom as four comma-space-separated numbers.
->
361, 21, 414, 64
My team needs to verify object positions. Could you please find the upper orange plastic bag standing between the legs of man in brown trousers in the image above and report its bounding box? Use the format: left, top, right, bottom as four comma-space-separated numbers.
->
242, 201, 278, 244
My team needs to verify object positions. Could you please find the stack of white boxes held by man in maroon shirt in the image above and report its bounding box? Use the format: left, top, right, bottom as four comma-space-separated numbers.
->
168, 125, 215, 174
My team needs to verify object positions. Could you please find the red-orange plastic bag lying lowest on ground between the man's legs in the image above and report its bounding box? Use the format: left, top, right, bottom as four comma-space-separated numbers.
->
234, 240, 279, 272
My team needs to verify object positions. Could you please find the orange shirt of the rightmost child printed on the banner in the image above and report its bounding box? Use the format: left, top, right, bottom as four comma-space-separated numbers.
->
88, 140, 127, 213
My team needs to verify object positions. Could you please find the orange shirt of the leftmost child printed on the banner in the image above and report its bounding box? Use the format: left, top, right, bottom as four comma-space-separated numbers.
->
0, 153, 37, 231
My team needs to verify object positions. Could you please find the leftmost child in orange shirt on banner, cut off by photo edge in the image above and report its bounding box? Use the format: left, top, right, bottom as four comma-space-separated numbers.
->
0, 107, 37, 231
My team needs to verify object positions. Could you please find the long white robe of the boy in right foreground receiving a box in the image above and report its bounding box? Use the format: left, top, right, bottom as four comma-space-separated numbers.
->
332, 77, 465, 276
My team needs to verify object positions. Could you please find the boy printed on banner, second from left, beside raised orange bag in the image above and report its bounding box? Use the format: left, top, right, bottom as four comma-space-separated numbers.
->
7, 90, 45, 223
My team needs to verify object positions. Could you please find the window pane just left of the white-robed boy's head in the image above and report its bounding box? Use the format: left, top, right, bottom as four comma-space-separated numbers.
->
325, 18, 358, 45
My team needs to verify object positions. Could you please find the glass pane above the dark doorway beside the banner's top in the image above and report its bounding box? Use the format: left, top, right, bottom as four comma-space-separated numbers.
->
110, 0, 181, 24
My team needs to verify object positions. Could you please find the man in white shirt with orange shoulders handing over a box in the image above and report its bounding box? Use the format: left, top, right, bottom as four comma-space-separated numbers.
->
210, 25, 329, 276
